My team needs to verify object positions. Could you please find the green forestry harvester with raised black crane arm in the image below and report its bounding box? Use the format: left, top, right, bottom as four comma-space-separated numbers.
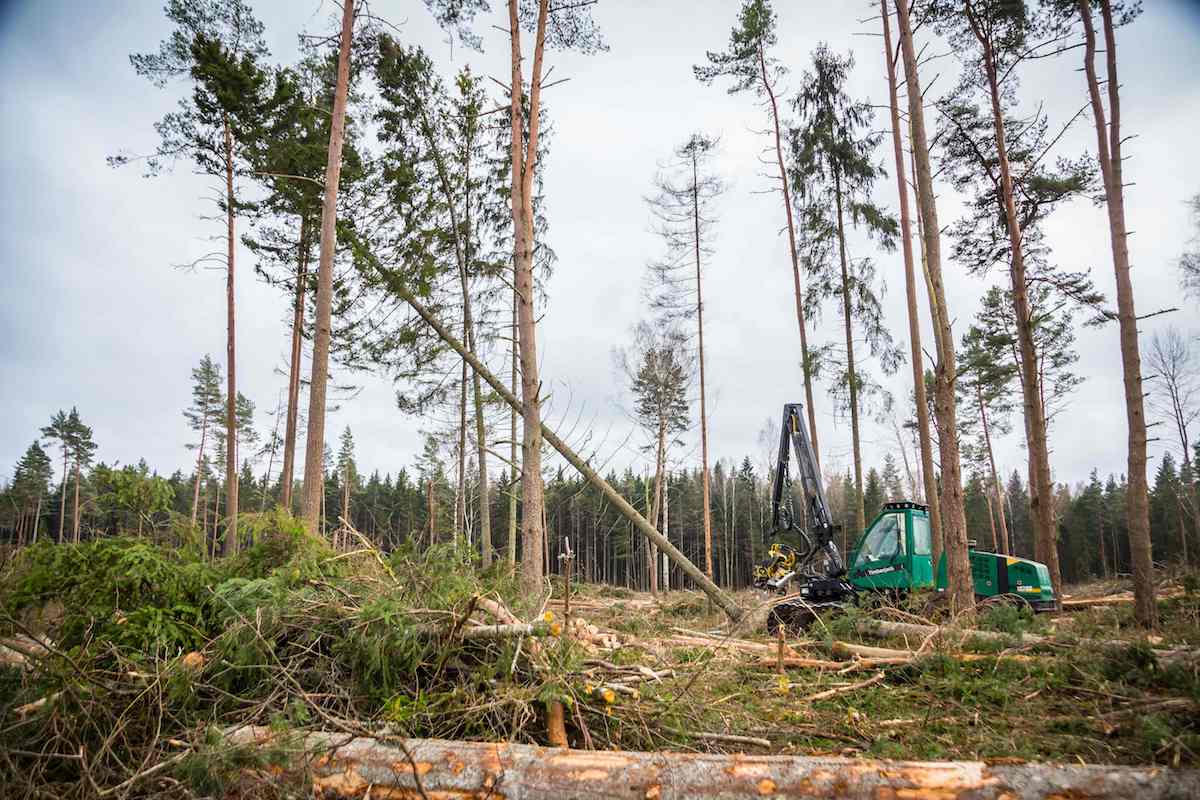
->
754, 403, 1057, 631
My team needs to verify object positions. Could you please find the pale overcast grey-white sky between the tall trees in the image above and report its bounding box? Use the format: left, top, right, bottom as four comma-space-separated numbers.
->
0, 0, 1200, 496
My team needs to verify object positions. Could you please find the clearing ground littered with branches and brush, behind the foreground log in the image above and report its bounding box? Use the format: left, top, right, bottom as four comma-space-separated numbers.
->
0, 515, 1200, 800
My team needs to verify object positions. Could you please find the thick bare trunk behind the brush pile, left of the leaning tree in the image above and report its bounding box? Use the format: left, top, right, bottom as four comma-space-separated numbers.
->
304, 0, 354, 533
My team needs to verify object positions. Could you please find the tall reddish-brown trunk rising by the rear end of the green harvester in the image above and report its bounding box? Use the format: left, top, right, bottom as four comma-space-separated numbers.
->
966, 0, 1065, 597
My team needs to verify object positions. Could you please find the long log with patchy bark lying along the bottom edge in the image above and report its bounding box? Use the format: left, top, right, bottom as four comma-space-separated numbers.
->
229, 728, 1200, 800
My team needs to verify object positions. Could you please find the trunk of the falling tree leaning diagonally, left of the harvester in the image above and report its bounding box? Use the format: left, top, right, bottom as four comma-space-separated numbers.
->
388, 275, 745, 622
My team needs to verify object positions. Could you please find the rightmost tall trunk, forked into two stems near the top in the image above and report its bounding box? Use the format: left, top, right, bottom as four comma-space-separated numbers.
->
1079, 0, 1158, 627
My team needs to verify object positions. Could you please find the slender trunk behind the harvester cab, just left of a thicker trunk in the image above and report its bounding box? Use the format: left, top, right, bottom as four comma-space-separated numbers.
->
880, 0, 941, 534
